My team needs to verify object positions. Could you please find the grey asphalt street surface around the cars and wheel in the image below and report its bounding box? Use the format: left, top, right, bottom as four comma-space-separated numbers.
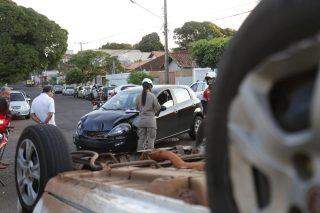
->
0, 85, 194, 212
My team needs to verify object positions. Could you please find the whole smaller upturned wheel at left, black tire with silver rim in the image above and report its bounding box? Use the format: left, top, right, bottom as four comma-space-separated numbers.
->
15, 125, 72, 212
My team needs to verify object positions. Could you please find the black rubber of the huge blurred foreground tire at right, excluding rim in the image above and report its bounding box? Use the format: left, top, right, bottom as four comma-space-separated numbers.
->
207, 0, 320, 213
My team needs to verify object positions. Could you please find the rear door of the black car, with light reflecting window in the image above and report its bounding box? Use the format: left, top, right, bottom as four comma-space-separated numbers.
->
172, 87, 196, 132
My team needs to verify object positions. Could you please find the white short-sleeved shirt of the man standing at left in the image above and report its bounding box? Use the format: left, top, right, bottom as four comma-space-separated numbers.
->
31, 93, 56, 125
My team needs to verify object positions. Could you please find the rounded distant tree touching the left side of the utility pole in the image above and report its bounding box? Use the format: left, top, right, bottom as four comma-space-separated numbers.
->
135, 33, 164, 52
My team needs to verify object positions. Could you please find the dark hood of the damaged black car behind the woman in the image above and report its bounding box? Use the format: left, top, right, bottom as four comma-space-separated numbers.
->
81, 110, 138, 132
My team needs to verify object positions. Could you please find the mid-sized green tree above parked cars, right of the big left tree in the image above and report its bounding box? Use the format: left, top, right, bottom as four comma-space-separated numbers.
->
69, 50, 123, 81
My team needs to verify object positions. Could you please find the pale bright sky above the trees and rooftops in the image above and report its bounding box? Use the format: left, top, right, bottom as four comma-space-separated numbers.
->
13, 0, 257, 52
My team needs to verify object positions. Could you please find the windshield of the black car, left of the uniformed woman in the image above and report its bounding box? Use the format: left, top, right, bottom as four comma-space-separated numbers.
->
102, 91, 139, 110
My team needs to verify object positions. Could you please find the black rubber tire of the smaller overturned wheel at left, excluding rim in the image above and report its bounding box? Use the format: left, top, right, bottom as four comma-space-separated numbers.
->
15, 125, 72, 212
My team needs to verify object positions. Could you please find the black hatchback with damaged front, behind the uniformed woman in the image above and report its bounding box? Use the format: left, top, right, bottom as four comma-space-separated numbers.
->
74, 85, 203, 152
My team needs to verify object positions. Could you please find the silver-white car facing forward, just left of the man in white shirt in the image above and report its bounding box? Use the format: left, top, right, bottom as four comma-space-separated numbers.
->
9, 91, 30, 119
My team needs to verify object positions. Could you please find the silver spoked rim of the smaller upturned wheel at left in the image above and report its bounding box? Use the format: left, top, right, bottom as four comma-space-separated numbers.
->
16, 139, 40, 206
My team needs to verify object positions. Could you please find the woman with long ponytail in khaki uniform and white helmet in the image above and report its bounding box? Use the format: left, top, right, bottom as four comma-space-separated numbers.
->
136, 78, 161, 152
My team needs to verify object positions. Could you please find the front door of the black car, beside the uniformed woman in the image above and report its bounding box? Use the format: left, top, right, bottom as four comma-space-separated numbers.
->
157, 89, 178, 140
